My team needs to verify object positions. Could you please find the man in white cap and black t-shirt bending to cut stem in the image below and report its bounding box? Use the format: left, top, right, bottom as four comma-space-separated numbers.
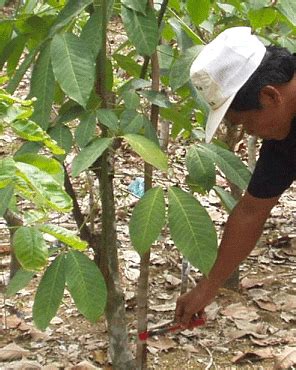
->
175, 27, 296, 325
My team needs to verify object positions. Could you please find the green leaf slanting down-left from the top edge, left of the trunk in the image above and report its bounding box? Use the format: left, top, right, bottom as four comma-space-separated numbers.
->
49, 0, 93, 37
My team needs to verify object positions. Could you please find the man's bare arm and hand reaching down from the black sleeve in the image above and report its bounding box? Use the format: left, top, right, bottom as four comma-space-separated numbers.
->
176, 192, 279, 325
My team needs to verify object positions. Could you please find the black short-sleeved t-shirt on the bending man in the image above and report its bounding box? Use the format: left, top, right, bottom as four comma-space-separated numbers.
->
248, 119, 296, 198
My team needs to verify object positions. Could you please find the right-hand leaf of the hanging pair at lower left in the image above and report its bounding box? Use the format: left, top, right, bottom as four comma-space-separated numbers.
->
66, 251, 107, 322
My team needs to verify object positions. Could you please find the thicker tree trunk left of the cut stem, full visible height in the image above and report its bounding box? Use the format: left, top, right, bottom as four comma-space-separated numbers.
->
94, 0, 135, 370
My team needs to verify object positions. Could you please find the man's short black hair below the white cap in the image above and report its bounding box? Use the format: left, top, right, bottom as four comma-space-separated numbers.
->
230, 46, 296, 111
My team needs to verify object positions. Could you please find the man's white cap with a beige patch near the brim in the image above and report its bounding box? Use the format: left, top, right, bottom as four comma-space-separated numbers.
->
190, 27, 266, 142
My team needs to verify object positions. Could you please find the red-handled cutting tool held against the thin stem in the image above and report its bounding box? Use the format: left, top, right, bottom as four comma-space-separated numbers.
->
138, 311, 206, 341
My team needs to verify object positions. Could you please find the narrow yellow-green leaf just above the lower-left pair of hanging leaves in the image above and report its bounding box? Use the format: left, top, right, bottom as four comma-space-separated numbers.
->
38, 224, 87, 250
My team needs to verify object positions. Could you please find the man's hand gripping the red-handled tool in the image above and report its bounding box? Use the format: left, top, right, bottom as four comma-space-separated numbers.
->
175, 279, 217, 327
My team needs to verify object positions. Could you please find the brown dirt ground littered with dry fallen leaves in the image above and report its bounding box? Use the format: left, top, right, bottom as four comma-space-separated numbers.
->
0, 139, 296, 370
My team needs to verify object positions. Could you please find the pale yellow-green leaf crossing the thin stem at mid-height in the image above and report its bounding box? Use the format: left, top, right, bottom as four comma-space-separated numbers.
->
123, 134, 168, 171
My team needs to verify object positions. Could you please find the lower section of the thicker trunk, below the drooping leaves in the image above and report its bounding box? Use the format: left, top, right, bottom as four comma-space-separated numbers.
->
99, 152, 135, 370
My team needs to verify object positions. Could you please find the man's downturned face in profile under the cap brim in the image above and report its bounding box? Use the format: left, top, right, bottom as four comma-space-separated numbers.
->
225, 107, 293, 140
